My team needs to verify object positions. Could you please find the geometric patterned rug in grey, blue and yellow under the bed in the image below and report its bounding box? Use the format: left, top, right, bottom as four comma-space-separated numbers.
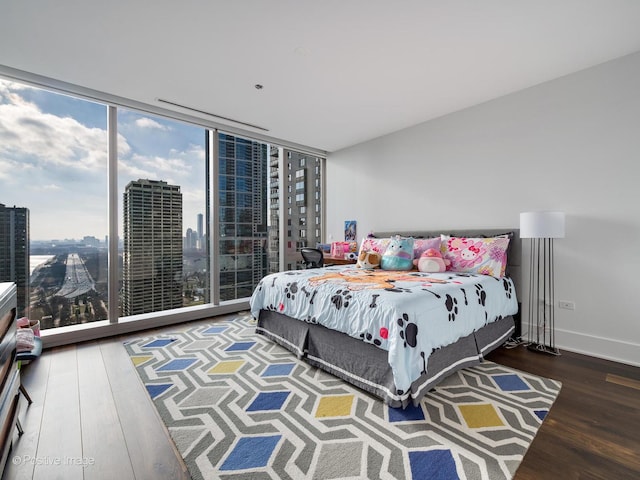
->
125, 312, 560, 480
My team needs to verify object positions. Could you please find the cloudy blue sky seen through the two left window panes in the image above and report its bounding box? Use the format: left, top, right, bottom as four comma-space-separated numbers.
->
0, 79, 206, 244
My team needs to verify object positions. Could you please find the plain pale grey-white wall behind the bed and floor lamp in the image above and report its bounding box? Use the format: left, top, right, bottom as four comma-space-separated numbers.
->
327, 53, 640, 365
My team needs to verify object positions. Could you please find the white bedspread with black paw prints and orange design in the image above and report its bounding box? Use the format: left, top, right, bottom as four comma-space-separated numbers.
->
250, 266, 518, 392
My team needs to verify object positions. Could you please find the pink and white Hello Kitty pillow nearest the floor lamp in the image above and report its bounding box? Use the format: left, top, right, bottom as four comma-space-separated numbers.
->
440, 235, 509, 278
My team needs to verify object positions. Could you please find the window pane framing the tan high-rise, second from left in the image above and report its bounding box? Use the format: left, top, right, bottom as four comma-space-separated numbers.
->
118, 108, 210, 316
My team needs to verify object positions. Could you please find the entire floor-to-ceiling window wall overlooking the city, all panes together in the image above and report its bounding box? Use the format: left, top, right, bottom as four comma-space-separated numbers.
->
0, 79, 322, 338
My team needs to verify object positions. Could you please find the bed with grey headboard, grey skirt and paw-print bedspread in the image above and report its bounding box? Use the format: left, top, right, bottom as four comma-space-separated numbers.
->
250, 229, 521, 407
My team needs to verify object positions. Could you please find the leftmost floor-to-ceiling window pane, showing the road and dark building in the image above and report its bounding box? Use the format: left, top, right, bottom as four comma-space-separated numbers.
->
0, 79, 109, 329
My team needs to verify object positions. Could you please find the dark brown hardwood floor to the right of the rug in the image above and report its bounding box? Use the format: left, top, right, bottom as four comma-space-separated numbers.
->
488, 347, 640, 480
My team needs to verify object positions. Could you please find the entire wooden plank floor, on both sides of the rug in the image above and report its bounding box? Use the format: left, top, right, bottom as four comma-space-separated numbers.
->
2, 317, 640, 480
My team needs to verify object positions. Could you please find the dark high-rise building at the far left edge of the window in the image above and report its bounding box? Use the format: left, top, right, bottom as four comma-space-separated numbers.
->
0, 203, 30, 316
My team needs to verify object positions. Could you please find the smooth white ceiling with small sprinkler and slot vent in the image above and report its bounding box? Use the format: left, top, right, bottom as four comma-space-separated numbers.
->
0, 0, 640, 152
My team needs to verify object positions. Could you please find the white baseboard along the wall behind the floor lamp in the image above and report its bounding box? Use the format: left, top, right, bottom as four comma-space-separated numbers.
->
522, 322, 640, 367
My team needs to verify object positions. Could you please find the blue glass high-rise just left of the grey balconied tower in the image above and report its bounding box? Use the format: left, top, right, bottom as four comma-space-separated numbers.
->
218, 133, 268, 300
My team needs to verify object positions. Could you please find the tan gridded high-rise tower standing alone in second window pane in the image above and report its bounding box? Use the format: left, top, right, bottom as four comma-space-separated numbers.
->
122, 179, 183, 316
